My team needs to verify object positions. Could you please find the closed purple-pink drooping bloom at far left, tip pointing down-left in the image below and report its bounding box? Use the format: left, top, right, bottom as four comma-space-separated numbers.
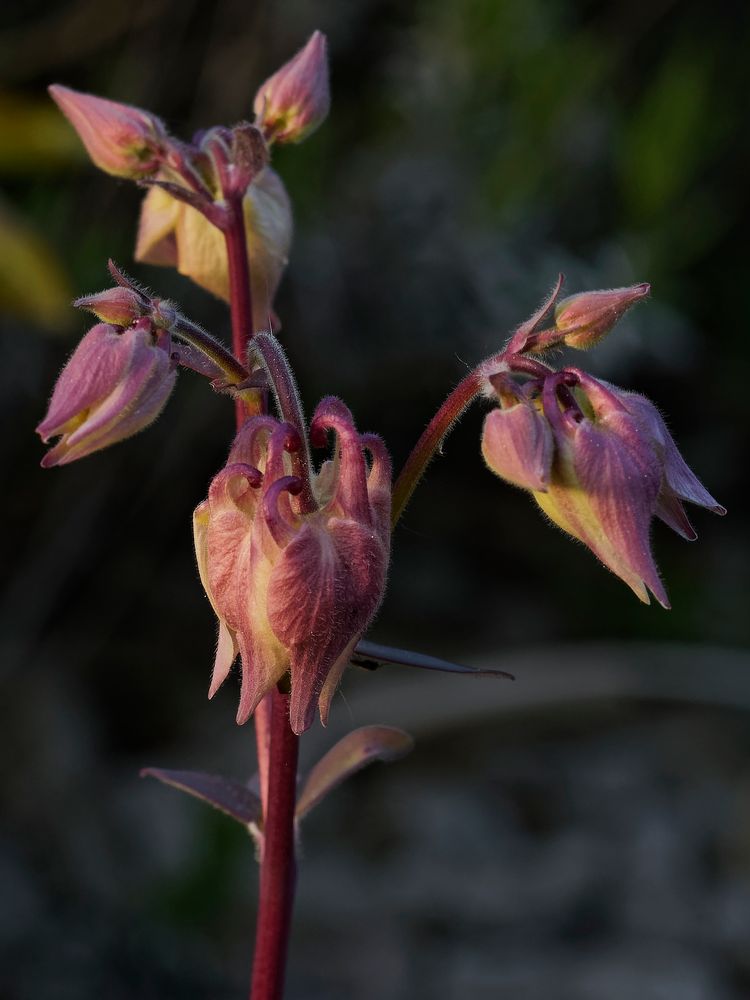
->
37, 319, 177, 468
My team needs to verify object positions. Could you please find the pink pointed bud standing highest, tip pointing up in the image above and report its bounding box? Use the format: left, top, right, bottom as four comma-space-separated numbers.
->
253, 31, 331, 142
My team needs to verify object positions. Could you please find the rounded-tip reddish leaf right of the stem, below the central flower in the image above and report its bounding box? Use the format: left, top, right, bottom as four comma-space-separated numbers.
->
295, 726, 414, 819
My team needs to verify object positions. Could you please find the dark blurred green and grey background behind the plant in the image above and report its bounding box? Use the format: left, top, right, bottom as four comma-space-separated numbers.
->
0, 0, 750, 1000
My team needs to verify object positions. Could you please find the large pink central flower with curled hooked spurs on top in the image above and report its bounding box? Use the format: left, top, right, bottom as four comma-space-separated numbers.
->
193, 398, 391, 733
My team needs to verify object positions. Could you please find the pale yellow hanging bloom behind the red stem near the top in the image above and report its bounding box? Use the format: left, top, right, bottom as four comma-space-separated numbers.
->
135, 167, 292, 330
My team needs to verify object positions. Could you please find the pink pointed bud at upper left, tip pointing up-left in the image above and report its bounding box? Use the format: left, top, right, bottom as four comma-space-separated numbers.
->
49, 84, 167, 180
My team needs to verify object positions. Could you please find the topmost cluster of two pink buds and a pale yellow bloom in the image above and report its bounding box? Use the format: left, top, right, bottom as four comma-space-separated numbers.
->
50, 31, 329, 329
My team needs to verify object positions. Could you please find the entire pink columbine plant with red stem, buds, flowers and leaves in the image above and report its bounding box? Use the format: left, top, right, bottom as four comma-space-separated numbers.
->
38, 32, 724, 1000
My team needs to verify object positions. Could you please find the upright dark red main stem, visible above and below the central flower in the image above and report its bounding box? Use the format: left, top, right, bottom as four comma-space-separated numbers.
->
224, 189, 299, 1000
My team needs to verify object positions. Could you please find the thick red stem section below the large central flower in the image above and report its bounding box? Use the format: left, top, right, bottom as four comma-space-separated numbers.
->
250, 691, 299, 1000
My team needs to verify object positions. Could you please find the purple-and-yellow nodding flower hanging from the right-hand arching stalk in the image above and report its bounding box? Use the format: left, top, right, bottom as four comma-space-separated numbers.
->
482, 369, 724, 608
